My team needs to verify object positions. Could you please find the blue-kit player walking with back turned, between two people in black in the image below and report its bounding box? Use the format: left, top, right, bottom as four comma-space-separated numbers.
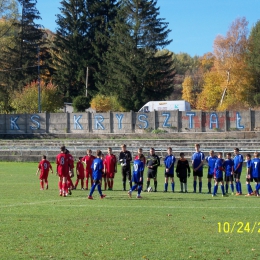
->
128, 154, 144, 199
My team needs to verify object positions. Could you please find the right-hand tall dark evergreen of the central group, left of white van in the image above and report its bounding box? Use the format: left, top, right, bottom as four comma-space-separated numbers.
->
98, 0, 174, 110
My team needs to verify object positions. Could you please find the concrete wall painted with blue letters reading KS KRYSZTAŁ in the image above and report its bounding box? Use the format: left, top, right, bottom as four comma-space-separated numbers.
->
0, 110, 260, 135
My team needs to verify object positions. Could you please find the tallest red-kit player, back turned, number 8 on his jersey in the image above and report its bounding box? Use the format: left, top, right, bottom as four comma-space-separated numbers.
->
56, 146, 73, 197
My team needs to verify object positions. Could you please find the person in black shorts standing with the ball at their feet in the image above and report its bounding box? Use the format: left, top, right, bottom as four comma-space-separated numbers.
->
145, 148, 160, 192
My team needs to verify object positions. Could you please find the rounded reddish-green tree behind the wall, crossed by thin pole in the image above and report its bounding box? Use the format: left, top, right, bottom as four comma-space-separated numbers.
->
11, 81, 63, 113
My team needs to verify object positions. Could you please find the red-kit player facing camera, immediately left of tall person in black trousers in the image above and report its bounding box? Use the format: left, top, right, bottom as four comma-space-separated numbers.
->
105, 147, 117, 190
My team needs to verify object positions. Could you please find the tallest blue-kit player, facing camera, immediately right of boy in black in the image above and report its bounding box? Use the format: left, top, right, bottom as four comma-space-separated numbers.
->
191, 144, 205, 193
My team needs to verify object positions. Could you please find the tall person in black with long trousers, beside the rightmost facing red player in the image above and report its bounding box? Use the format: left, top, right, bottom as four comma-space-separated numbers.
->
119, 144, 132, 191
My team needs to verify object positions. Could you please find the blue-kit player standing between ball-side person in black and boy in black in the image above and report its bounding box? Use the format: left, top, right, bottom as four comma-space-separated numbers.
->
164, 147, 176, 192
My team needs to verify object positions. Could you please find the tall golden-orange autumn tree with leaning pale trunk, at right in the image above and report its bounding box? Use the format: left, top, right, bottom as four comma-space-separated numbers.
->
214, 17, 252, 110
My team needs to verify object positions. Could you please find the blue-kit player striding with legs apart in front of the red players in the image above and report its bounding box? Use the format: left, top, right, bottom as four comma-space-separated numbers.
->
88, 150, 106, 200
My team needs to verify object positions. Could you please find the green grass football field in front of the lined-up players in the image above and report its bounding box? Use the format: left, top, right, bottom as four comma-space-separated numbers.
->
0, 162, 260, 260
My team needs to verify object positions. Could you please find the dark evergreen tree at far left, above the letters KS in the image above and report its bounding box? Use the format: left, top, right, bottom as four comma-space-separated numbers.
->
1, 0, 44, 90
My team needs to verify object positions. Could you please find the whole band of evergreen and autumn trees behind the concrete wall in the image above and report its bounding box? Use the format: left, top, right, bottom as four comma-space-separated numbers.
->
0, 0, 260, 113
